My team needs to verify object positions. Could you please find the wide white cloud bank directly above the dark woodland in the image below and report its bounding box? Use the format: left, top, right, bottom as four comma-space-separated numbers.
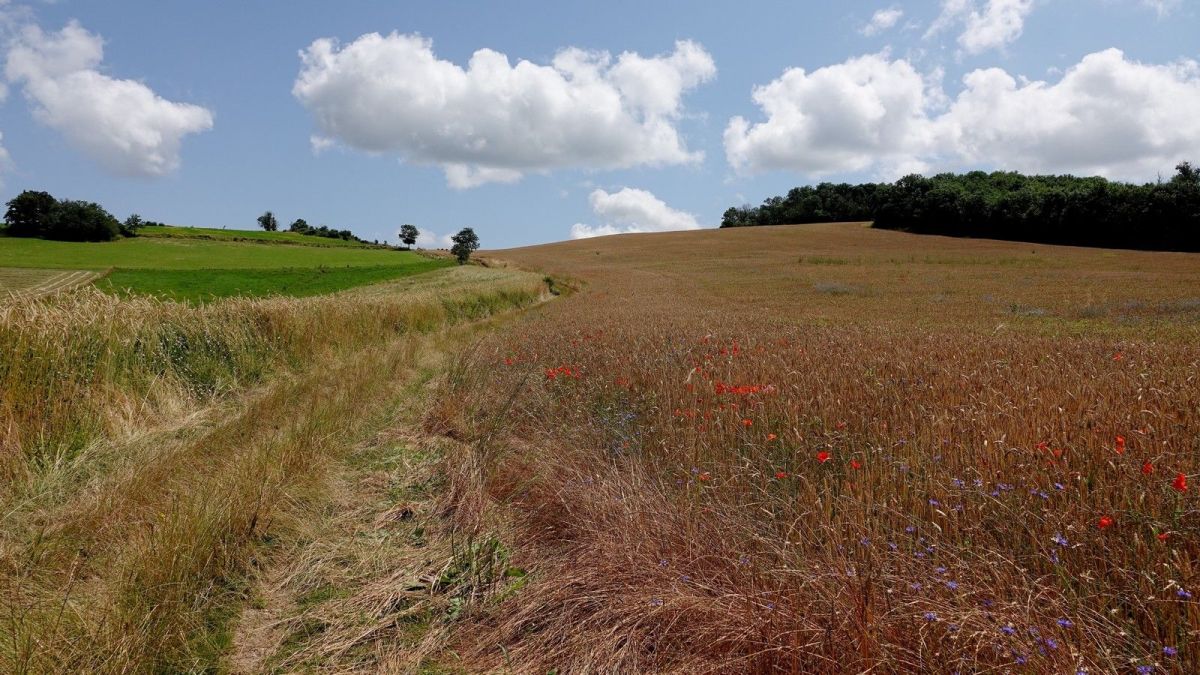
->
725, 49, 1200, 179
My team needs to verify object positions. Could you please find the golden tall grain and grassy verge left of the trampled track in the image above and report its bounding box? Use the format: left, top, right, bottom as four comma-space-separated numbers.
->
0, 268, 545, 673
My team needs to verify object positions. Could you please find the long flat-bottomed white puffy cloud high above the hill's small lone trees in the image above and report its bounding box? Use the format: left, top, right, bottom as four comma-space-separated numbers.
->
293, 32, 716, 187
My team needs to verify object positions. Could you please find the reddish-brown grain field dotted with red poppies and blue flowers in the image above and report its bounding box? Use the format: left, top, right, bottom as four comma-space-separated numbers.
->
430, 225, 1200, 673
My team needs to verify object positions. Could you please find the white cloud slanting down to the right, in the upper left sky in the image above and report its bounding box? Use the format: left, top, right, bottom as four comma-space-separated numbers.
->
5, 22, 212, 175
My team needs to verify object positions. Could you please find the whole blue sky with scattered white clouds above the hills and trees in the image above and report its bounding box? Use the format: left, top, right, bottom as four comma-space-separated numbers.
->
0, 0, 1200, 247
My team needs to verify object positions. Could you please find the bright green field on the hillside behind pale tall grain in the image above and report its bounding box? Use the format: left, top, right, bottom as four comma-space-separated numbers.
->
0, 227, 452, 301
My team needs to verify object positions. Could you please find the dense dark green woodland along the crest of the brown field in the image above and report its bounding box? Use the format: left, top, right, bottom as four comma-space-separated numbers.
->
721, 162, 1200, 251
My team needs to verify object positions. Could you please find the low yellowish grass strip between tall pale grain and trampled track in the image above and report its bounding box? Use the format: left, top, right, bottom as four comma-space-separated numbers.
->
0, 266, 552, 673
